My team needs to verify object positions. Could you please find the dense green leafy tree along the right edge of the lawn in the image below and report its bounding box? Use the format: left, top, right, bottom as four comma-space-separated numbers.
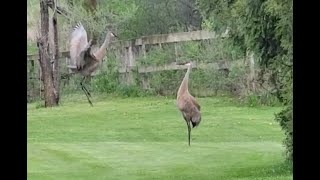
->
196, 0, 293, 160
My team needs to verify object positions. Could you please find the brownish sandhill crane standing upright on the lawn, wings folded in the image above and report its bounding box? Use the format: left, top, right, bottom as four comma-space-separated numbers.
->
177, 62, 201, 146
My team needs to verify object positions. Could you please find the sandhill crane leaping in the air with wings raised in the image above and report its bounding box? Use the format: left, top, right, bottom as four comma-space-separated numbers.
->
68, 22, 117, 106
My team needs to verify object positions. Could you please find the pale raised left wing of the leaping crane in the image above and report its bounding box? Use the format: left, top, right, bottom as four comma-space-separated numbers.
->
70, 23, 88, 65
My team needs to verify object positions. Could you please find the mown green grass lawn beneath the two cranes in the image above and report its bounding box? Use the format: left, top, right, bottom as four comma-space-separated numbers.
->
27, 94, 292, 180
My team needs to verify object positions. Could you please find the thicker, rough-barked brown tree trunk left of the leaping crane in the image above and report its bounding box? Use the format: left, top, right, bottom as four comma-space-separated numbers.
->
38, 0, 58, 107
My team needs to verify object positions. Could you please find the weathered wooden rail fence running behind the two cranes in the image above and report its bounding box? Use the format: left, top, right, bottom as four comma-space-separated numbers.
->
27, 30, 228, 94
